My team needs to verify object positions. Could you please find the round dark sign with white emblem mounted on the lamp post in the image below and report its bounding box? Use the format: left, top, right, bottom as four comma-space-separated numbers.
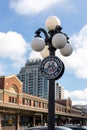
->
41, 56, 64, 79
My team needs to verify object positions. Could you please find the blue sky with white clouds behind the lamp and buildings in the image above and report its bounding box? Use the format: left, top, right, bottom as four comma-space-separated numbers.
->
0, 0, 87, 105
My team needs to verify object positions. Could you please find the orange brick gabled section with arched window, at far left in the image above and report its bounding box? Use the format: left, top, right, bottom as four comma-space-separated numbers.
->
0, 75, 22, 104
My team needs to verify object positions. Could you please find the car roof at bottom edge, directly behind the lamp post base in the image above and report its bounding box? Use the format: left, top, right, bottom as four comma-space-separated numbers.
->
25, 126, 72, 130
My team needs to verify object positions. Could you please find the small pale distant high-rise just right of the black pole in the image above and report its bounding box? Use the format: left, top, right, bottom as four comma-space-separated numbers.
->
55, 83, 64, 100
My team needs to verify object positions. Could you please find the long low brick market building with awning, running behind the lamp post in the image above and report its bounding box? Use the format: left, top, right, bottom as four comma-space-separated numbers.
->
0, 75, 87, 130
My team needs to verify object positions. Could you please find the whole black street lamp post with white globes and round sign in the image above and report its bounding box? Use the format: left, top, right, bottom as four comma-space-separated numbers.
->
31, 16, 72, 130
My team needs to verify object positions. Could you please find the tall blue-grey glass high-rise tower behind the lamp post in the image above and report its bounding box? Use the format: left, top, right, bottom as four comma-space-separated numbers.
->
17, 59, 49, 99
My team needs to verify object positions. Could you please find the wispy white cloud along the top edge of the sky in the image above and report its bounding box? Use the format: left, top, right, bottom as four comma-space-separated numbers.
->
10, 0, 67, 15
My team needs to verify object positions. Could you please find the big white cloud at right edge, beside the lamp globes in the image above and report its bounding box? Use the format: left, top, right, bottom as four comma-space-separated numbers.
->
53, 25, 87, 79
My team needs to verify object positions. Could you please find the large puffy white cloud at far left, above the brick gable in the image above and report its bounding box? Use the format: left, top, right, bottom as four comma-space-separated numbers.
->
0, 31, 29, 72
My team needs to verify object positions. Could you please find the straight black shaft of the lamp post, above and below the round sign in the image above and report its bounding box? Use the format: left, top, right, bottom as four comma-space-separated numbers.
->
48, 44, 55, 130
